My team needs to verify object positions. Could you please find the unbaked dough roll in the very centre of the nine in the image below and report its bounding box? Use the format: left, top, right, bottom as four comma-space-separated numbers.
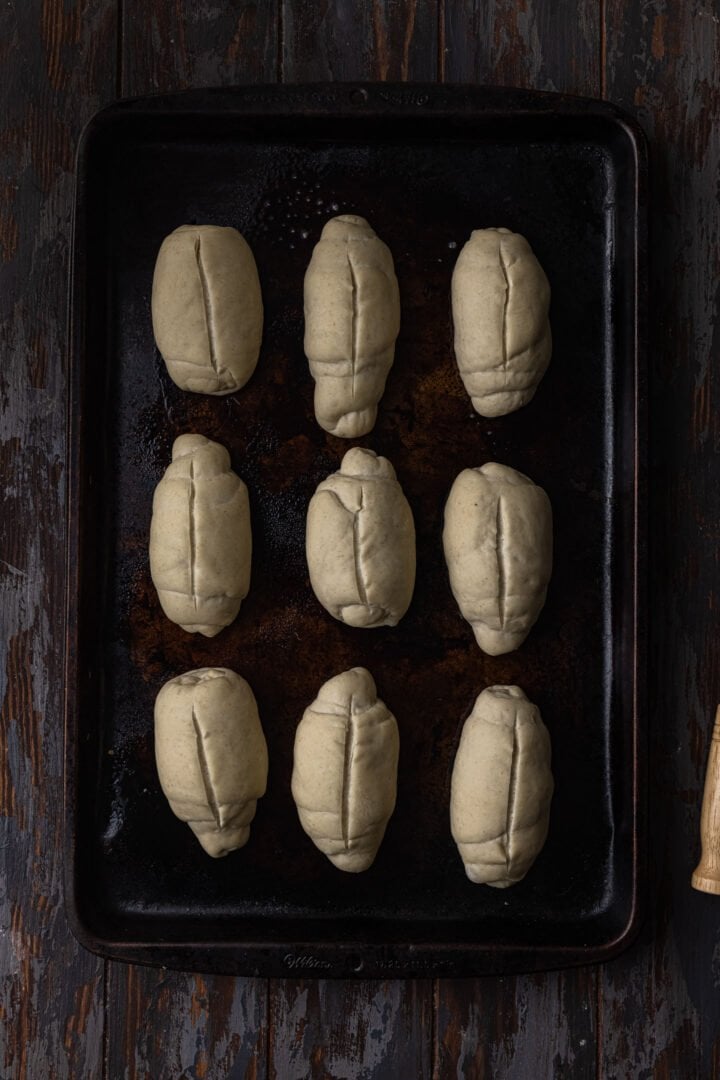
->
305, 447, 416, 627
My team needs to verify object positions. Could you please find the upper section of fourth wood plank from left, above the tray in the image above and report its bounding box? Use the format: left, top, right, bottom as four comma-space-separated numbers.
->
441, 0, 600, 95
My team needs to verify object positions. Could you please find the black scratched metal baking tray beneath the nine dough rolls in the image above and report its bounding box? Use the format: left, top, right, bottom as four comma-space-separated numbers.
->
67, 87, 641, 974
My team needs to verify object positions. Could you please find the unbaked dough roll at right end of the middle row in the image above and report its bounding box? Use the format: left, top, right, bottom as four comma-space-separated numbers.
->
443, 461, 553, 657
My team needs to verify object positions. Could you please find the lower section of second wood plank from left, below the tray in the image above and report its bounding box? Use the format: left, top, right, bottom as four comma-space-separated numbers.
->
106, 964, 267, 1080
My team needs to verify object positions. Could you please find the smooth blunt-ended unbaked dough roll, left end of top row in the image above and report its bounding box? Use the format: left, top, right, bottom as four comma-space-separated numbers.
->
152, 225, 262, 394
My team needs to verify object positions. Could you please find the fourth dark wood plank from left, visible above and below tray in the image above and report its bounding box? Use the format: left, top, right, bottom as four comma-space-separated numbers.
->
434, 0, 600, 1080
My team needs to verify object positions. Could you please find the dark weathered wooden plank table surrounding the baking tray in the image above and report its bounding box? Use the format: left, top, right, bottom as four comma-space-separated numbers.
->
0, 0, 720, 1080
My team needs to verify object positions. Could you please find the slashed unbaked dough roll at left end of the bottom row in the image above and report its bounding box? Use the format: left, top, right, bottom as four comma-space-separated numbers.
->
155, 667, 268, 859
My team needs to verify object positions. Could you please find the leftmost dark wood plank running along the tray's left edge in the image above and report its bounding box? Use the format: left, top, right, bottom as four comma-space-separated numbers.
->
0, 0, 116, 1080
